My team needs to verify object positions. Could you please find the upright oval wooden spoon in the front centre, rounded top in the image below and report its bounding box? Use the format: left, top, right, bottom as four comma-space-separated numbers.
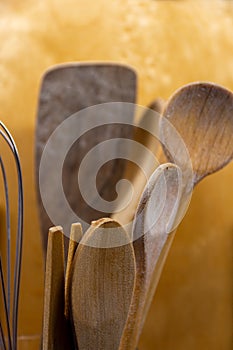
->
71, 219, 135, 350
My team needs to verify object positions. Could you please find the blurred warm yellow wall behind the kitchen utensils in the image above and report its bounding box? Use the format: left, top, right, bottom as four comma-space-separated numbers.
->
0, 0, 233, 350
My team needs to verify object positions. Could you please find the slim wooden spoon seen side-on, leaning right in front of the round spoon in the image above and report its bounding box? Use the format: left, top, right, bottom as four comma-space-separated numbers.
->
119, 163, 182, 350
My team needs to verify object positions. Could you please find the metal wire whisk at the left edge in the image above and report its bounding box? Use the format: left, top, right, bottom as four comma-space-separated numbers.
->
0, 121, 23, 350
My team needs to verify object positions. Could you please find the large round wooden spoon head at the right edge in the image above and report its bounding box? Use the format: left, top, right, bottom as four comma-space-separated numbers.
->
163, 82, 233, 184
